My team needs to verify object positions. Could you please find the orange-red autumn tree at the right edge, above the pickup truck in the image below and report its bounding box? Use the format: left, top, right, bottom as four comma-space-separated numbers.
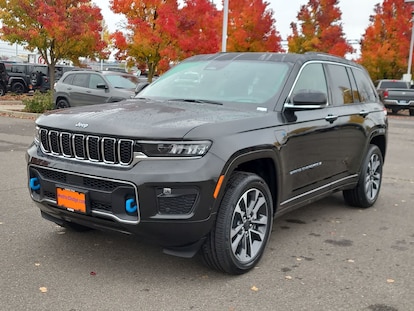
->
360, 0, 414, 80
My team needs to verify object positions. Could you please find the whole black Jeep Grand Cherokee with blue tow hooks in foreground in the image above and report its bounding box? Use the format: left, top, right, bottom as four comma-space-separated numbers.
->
27, 53, 387, 274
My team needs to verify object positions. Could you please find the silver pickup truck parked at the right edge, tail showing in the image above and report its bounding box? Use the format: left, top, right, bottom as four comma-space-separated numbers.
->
375, 80, 414, 116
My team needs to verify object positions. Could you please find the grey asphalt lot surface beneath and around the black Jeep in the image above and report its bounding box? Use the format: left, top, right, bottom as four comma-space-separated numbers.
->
0, 116, 414, 311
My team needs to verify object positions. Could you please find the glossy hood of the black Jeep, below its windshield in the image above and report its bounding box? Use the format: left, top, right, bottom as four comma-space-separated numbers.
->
36, 99, 272, 139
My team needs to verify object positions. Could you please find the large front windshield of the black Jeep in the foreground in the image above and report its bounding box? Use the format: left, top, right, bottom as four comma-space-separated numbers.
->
138, 60, 289, 106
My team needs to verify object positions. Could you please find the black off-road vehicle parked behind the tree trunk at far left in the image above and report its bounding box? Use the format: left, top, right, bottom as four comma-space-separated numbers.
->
5, 62, 75, 94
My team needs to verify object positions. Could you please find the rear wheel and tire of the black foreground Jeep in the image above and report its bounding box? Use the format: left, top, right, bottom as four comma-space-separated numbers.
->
343, 145, 384, 208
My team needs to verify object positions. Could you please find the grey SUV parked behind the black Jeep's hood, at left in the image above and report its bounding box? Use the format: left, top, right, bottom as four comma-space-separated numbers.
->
53, 70, 139, 108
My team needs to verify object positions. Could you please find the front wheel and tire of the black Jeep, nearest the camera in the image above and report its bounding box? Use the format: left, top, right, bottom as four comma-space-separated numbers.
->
202, 172, 273, 274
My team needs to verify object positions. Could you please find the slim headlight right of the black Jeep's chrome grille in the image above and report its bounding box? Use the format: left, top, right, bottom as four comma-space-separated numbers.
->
137, 141, 211, 157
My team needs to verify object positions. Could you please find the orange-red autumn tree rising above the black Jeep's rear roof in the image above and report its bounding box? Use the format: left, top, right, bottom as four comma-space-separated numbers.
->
288, 0, 353, 57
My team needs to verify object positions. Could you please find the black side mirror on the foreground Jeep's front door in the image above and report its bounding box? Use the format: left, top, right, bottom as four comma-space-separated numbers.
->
285, 91, 328, 110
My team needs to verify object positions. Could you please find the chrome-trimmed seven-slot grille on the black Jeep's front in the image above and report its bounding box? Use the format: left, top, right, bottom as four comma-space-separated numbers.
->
39, 129, 134, 166
